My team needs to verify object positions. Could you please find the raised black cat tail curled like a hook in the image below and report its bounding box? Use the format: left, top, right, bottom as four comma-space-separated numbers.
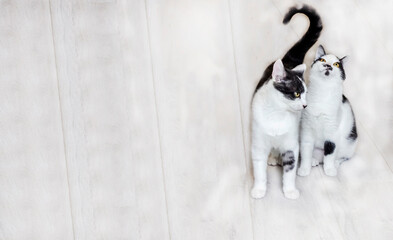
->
282, 5, 322, 68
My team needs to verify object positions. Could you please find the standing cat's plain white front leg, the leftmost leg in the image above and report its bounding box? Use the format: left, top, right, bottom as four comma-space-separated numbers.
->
251, 137, 270, 199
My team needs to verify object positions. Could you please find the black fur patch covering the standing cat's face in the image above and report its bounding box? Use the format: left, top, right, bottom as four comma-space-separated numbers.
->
273, 70, 305, 100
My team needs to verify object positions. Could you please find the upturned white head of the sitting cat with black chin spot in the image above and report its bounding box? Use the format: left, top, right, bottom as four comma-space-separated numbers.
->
311, 45, 346, 81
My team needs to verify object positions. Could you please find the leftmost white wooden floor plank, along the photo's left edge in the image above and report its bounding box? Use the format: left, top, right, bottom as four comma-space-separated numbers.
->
0, 1, 73, 240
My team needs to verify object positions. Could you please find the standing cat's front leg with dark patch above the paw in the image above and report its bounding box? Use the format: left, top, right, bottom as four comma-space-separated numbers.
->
281, 145, 300, 199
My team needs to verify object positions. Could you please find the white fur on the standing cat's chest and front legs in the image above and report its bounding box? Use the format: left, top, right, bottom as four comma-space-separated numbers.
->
251, 60, 306, 199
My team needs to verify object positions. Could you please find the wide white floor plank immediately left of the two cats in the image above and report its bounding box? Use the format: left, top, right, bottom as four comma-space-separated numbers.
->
147, 0, 253, 239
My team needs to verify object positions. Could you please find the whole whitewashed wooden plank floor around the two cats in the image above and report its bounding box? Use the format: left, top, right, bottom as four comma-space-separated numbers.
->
0, 0, 393, 240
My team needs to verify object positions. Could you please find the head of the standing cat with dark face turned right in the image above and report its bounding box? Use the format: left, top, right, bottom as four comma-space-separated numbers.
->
272, 61, 307, 111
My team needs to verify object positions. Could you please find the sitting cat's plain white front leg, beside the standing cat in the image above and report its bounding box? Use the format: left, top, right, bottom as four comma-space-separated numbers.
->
297, 125, 315, 177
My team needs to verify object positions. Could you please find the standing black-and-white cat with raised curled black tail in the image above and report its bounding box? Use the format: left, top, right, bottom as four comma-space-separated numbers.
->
251, 5, 322, 199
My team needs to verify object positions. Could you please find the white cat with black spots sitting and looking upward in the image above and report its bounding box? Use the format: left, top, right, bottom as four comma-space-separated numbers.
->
298, 45, 358, 176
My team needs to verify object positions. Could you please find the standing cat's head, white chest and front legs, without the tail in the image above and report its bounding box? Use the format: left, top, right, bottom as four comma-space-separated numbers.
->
251, 60, 307, 199
